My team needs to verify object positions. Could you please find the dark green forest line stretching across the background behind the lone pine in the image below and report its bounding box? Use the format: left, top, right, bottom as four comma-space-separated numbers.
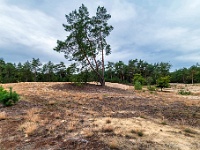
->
0, 58, 200, 85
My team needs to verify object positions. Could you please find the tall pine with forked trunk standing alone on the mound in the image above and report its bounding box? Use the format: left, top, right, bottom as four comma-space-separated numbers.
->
54, 4, 113, 86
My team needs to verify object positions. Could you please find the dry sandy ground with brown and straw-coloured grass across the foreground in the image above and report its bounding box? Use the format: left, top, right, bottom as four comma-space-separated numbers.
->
0, 83, 200, 150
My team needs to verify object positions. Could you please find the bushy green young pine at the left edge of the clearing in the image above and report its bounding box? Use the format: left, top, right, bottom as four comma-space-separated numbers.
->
0, 86, 19, 106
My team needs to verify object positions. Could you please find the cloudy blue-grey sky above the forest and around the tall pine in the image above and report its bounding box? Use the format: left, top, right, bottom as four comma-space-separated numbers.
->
0, 0, 200, 70
